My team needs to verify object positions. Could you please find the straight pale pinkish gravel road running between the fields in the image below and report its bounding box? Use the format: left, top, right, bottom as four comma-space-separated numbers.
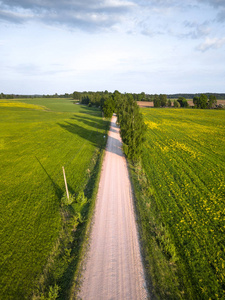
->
78, 116, 148, 300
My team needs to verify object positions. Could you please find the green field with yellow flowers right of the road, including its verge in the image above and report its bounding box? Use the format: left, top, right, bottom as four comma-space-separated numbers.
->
132, 108, 225, 299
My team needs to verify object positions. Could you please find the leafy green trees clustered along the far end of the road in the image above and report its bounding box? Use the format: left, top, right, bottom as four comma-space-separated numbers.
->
73, 91, 147, 161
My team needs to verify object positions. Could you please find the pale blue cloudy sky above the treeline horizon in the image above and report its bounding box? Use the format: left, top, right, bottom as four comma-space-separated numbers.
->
0, 0, 225, 94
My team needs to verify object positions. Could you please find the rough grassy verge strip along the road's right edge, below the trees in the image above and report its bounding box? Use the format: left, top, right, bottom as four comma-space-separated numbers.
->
129, 162, 189, 300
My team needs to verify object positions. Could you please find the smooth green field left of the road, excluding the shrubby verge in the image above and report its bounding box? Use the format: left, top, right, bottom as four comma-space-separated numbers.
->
0, 99, 108, 299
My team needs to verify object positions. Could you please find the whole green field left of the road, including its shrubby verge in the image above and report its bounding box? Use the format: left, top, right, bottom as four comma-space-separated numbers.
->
0, 98, 109, 300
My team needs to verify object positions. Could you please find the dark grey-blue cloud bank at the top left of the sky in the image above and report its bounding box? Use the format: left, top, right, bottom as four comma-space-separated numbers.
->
0, 0, 136, 32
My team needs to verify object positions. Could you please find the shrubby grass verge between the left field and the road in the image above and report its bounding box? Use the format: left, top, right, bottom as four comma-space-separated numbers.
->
33, 145, 109, 300
